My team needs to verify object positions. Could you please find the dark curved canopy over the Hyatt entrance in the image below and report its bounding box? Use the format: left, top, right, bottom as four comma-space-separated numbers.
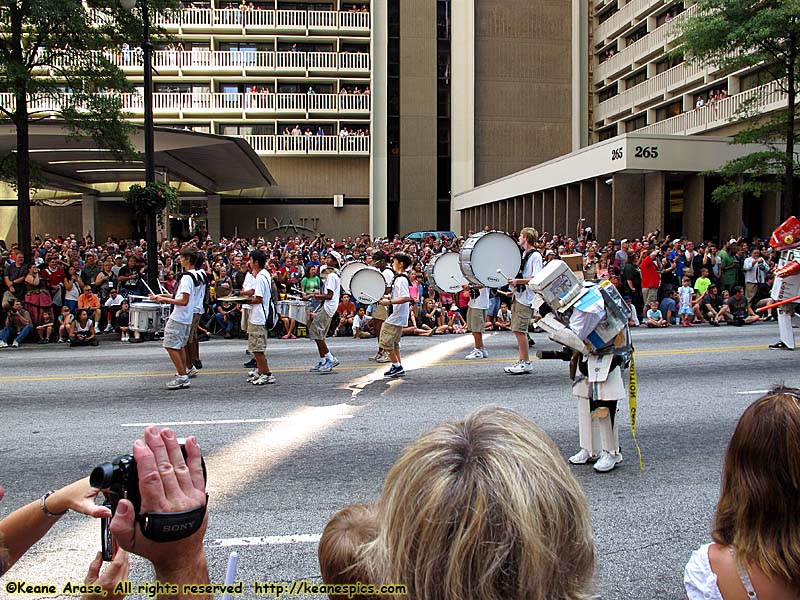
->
0, 120, 275, 194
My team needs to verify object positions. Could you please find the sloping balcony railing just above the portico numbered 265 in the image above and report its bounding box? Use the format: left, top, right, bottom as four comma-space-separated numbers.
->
636, 81, 786, 135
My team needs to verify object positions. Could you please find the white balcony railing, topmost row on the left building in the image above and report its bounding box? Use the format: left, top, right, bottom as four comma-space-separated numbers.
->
149, 8, 370, 32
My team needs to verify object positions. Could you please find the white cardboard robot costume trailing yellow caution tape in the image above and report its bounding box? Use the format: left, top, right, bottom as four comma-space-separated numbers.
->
529, 260, 635, 472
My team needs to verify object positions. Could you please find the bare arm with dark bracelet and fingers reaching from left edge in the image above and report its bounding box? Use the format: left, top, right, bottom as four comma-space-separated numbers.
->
0, 477, 130, 600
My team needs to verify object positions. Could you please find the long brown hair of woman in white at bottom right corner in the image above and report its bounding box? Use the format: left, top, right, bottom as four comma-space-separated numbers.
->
712, 387, 800, 594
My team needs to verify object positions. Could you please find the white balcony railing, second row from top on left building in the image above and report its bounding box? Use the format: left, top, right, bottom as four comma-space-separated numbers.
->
83, 49, 370, 73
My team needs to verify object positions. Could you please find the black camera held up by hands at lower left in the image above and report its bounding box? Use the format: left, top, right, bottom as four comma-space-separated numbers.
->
89, 442, 207, 561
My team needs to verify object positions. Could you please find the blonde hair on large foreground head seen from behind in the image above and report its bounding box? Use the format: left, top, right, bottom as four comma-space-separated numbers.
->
369, 407, 595, 600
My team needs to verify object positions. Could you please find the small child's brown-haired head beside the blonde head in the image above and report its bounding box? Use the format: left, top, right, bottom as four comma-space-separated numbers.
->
317, 504, 385, 600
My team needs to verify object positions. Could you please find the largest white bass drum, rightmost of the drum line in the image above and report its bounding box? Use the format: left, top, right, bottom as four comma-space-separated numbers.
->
459, 231, 522, 288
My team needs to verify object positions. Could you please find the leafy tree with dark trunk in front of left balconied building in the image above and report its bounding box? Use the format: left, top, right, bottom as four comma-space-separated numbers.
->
0, 0, 177, 257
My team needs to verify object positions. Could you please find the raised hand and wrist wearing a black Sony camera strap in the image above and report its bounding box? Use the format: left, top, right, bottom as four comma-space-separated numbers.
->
111, 426, 210, 600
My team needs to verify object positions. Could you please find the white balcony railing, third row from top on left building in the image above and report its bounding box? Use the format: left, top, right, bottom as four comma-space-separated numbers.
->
0, 92, 370, 117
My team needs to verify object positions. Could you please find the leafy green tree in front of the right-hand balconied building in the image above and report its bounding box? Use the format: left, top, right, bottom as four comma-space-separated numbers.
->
677, 0, 800, 219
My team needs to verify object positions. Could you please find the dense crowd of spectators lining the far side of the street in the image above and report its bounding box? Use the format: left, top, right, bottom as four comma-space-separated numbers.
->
0, 224, 778, 347
